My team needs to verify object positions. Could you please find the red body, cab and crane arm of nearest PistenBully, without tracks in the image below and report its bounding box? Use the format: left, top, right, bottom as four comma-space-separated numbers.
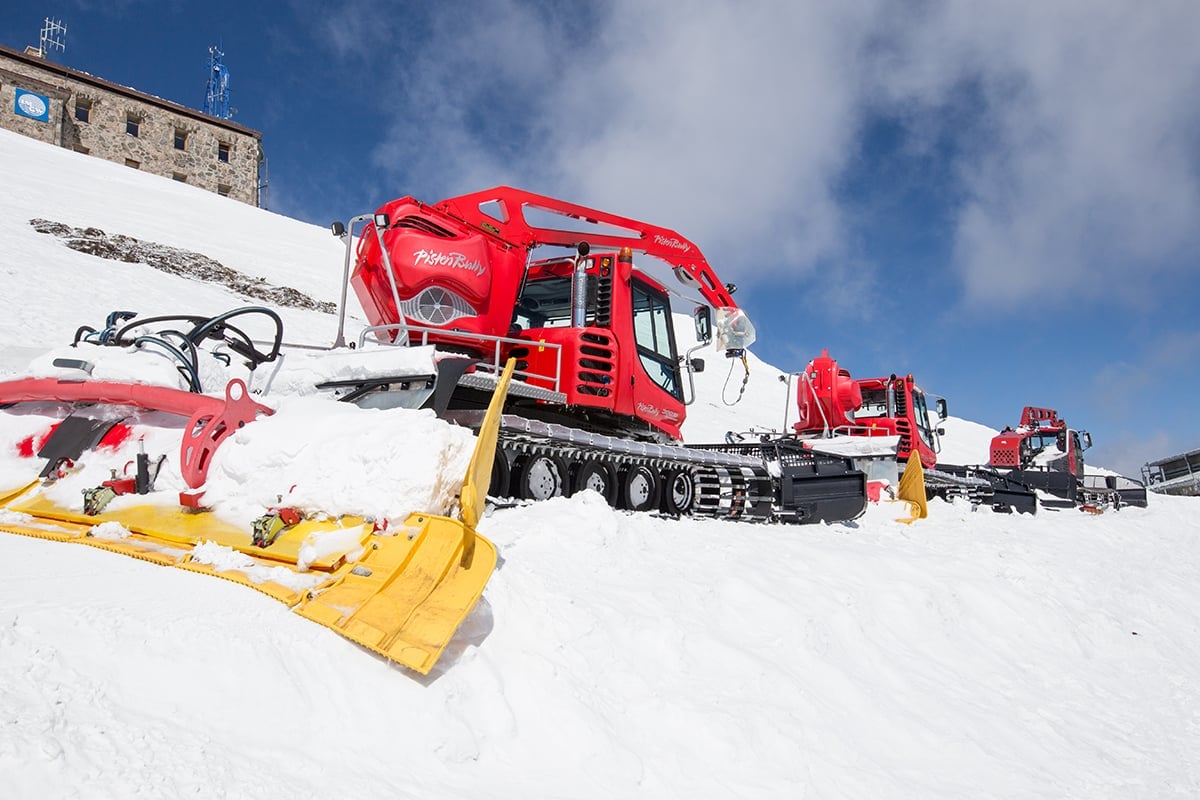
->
350, 187, 755, 441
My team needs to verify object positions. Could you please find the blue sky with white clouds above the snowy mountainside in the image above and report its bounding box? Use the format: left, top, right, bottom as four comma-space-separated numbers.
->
0, 0, 1200, 475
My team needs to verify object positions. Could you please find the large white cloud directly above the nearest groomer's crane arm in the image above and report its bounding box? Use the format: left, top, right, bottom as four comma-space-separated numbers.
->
355, 0, 870, 287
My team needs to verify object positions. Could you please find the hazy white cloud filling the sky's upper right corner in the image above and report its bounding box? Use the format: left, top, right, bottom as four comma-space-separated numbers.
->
881, 0, 1200, 305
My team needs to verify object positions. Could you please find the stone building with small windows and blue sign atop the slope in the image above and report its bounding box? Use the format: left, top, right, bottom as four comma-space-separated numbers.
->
0, 46, 263, 205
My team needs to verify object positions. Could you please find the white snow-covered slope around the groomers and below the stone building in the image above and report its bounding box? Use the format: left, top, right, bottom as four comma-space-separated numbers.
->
0, 131, 1200, 800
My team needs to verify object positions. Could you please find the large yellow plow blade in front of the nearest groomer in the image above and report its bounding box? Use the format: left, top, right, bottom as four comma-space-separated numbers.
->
0, 361, 514, 674
